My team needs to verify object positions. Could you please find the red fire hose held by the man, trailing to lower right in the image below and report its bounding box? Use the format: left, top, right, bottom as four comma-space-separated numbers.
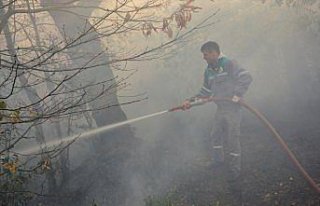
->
169, 97, 320, 194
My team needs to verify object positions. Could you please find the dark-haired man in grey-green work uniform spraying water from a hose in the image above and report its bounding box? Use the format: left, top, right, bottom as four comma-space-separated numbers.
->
183, 41, 252, 204
